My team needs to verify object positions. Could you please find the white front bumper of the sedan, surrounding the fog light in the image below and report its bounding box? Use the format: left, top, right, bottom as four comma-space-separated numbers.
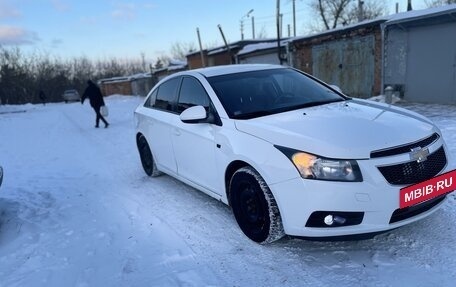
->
270, 141, 451, 237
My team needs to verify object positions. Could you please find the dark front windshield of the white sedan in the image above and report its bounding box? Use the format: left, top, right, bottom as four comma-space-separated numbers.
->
208, 69, 346, 119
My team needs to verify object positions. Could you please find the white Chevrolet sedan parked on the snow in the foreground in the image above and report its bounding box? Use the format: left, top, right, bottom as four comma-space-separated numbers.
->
135, 65, 449, 243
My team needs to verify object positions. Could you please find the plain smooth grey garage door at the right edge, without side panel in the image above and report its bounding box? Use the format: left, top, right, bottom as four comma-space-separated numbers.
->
404, 23, 456, 104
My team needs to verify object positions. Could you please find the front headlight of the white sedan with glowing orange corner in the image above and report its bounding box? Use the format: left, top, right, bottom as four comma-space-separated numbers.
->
276, 146, 363, 182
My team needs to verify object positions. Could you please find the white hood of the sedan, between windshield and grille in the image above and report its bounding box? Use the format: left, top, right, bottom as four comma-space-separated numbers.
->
235, 99, 438, 159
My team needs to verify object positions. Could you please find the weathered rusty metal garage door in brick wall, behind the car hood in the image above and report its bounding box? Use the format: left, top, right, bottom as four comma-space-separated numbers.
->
312, 35, 375, 98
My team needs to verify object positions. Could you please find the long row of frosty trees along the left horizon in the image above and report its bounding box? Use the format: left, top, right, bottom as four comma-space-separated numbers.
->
0, 46, 149, 104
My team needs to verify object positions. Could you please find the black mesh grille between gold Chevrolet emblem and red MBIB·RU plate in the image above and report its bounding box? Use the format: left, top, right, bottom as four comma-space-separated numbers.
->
378, 146, 447, 185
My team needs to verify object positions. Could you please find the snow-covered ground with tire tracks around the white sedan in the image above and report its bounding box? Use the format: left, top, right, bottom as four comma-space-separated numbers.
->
0, 96, 456, 287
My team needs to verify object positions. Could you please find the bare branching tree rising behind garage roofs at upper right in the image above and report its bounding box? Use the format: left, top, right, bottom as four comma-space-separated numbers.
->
310, 0, 388, 30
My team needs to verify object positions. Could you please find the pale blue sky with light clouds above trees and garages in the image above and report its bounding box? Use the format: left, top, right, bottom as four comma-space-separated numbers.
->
0, 0, 424, 59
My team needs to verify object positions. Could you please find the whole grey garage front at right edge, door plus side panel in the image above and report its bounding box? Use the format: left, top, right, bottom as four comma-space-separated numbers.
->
384, 22, 456, 104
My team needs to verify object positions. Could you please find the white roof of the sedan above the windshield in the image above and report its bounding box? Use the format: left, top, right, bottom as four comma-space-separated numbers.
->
185, 64, 286, 77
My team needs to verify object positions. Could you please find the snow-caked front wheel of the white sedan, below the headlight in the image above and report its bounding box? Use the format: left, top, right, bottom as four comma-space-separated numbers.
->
229, 166, 284, 244
